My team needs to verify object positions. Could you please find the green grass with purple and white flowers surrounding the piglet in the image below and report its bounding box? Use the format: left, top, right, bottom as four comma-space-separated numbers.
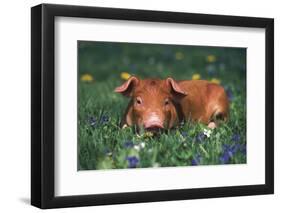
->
78, 42, 246, 170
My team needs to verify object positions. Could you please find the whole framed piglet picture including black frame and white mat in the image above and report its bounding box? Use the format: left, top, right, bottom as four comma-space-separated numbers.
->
31, 4, 274, 209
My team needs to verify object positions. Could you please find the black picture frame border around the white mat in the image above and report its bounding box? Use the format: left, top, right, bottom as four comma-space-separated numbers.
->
31, 4, 274, 209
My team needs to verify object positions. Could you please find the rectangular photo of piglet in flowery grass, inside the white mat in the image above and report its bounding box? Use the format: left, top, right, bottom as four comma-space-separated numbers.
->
78, 41, 247, 170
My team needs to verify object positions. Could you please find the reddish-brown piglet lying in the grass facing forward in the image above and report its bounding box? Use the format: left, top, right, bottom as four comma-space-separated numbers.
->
115, 76, 229, 131
